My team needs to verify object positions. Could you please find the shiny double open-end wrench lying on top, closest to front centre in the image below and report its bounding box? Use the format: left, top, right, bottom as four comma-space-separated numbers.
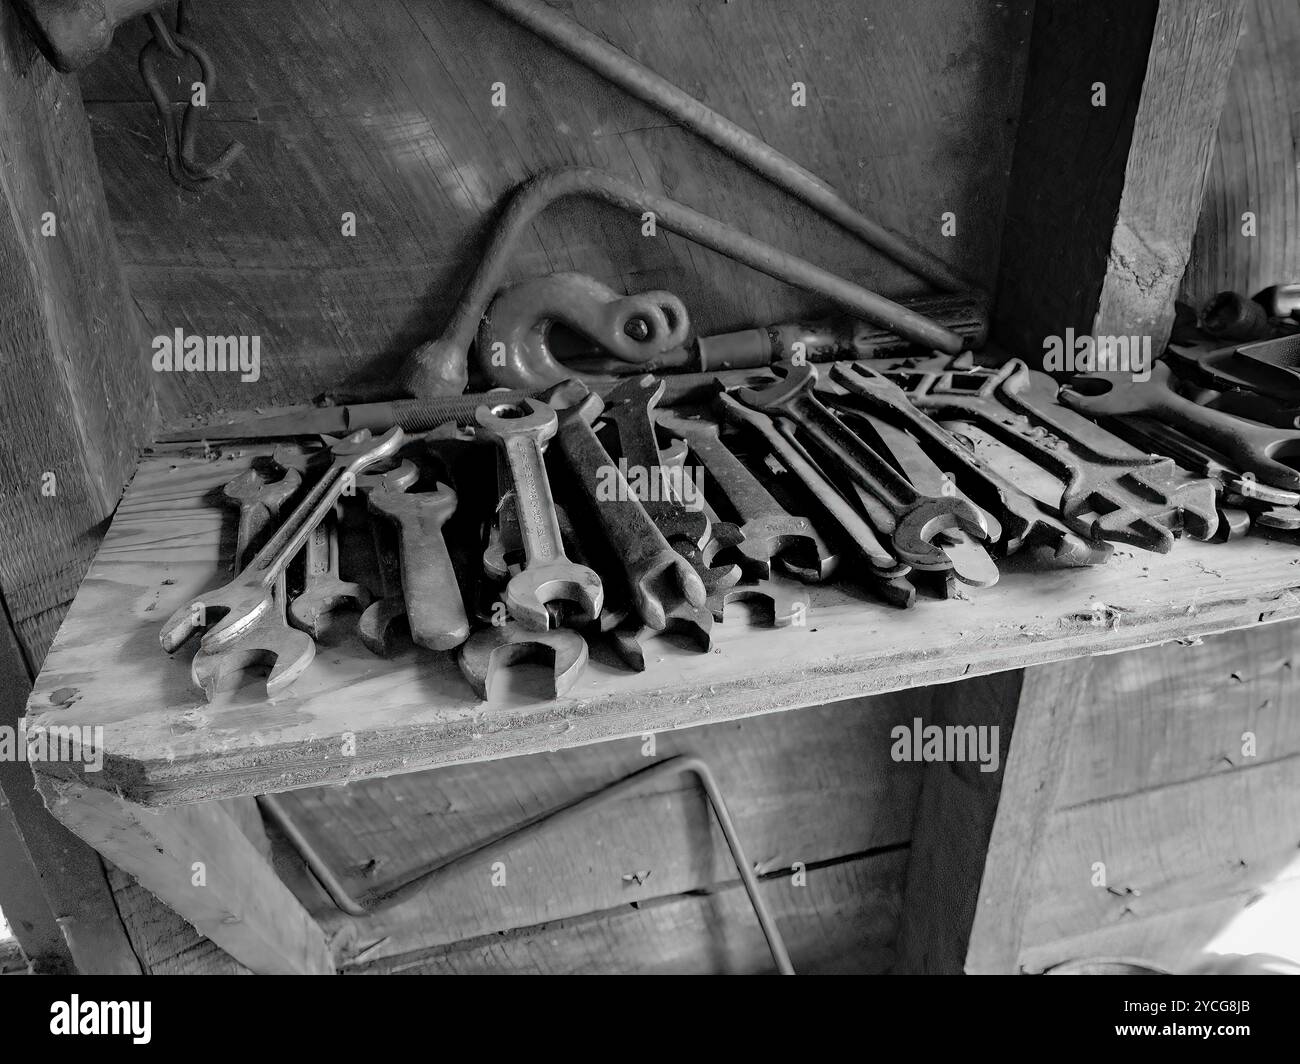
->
475, 399, 605, 631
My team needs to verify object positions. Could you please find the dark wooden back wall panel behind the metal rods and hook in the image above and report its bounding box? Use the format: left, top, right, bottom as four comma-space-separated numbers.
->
83, 0, 1028, 418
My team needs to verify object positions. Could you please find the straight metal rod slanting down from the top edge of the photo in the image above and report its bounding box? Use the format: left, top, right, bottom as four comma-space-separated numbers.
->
484, 0, 970, 291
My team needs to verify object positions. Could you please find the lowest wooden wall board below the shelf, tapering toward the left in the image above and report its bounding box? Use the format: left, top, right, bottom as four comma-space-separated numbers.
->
345, 853, 906, 976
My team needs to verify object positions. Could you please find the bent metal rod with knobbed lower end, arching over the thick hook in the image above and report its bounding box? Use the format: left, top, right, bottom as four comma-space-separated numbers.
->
402, 166, 965, 398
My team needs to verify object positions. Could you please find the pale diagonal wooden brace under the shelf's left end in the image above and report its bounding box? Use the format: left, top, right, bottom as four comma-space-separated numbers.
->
43, 778, 334, 974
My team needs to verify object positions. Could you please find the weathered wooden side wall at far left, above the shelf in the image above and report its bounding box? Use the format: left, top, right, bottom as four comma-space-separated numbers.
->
0, 5, 155, 663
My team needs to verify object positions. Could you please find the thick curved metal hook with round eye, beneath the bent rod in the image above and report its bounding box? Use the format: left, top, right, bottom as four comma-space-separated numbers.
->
475, 273, 690, 389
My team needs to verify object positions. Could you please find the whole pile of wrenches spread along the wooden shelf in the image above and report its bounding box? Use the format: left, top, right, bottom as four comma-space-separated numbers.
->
161, 340, 1281, 697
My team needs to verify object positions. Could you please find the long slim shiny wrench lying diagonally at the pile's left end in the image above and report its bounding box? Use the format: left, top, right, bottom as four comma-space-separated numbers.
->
159, 428, 402, 653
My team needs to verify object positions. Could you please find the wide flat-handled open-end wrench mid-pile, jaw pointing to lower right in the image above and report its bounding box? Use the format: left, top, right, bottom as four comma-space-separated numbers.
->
659, 405, 837, 580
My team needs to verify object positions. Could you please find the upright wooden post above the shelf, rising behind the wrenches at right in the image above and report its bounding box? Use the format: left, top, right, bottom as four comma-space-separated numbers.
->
995, 0, 1245, 366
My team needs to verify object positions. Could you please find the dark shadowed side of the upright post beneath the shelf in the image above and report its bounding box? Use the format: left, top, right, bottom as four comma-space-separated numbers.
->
896, 666, 1024, 974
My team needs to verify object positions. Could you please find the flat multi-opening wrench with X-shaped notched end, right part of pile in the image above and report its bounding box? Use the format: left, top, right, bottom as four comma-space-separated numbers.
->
889, 359, 1218, 553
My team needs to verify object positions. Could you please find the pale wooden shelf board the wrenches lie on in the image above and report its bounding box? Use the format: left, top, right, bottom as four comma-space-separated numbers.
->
29, 442, 1300, 805
